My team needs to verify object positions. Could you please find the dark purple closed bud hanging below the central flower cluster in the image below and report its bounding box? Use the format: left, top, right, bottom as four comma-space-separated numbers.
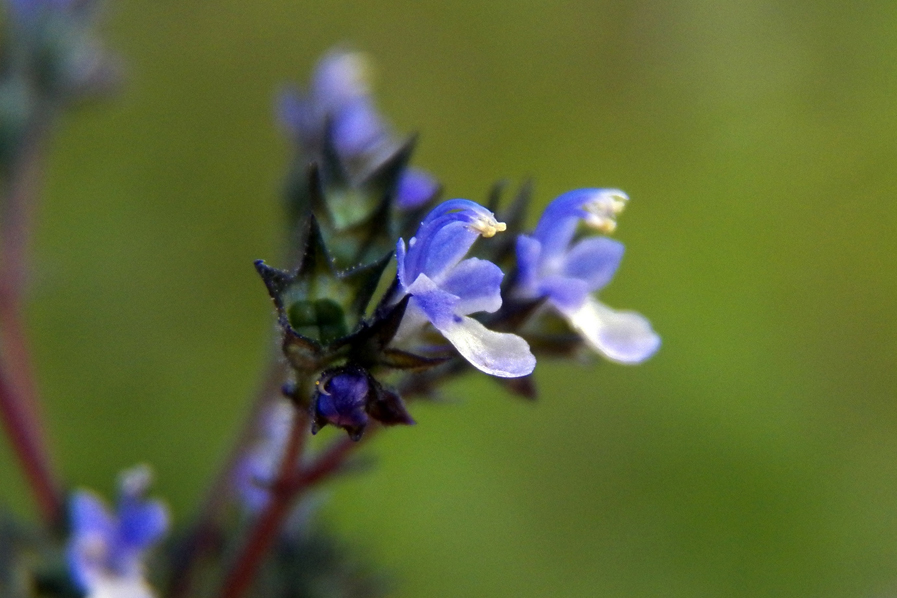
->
312, 365, 414, 440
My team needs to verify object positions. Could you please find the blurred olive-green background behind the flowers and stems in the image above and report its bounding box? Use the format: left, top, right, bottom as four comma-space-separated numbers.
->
0, 0, 897, 598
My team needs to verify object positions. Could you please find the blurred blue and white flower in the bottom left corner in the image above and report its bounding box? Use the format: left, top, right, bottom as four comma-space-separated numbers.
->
68, 467, 169, 598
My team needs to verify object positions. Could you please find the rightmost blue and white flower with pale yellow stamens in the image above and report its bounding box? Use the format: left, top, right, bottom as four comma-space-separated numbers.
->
515, 189, 660, 363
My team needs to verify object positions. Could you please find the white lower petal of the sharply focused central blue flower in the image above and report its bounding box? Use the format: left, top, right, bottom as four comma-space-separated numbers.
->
439, 316, 536, 378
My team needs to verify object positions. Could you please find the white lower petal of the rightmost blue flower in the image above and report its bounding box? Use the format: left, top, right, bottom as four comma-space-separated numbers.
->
562, 297, 660, 364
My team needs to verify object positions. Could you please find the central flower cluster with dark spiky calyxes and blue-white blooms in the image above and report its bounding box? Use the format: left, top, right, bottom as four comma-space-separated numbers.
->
257, 51, 660, 446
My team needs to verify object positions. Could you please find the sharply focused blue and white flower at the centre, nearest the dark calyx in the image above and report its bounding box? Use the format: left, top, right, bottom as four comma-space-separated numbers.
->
396, 199, 536, 378
